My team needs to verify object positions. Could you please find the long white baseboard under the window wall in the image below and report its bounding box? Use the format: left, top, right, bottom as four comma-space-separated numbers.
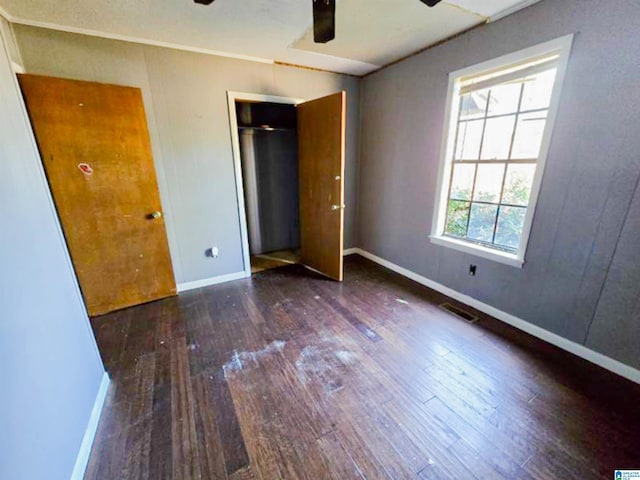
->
350, 248, 640, 383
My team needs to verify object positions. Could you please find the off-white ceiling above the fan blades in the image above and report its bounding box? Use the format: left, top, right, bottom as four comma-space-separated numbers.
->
0, 0, 538, 75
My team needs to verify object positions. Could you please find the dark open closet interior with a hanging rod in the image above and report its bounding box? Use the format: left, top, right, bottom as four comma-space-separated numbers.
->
235, 100, 300, 274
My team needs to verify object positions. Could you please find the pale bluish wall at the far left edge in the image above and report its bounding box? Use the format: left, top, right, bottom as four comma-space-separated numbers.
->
0, 29, 103, 480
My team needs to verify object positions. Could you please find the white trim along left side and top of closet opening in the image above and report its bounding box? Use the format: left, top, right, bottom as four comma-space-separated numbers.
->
227, 90, 306, 277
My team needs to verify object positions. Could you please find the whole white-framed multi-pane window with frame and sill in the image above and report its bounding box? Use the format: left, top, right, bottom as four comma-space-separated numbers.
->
431, 36, 572, 266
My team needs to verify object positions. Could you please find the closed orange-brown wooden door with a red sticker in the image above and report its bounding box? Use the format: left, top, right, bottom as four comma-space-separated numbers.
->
19, 75, 176, 315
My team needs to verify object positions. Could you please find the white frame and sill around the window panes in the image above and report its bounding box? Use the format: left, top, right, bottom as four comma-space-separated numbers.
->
429, 34, 574, 268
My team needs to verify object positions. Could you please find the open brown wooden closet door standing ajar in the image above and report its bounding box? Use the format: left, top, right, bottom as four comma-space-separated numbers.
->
298, 92, 346, 281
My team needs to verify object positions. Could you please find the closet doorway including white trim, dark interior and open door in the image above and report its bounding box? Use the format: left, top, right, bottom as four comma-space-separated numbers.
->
228, 92, 346, 281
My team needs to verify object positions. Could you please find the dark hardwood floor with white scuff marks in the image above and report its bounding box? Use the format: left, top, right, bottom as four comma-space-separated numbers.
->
86, 256, 640, 480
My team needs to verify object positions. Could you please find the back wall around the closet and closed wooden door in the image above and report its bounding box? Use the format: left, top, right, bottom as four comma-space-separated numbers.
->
14, 25, 360, 283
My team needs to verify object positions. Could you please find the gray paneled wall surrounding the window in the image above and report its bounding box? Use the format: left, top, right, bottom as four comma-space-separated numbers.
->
357, 0, 640, 367
